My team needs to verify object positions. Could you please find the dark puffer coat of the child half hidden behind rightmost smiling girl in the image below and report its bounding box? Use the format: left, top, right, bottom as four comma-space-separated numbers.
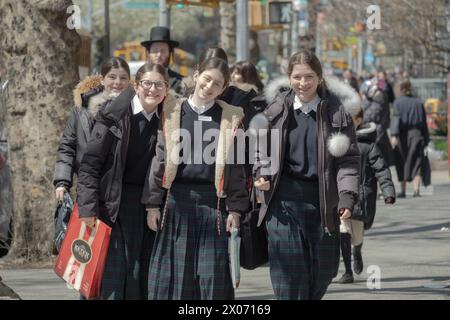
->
352, 122, 395, 230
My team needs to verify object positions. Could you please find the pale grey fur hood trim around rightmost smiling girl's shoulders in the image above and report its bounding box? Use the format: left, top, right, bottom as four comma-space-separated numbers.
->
264, 76, 361, 116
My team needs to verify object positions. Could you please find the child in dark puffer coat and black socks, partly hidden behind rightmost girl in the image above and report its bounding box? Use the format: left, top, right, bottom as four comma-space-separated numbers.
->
339, 109, 395, 283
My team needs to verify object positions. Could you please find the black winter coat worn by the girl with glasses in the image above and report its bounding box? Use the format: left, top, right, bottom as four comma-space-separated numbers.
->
77, 88, 156, 222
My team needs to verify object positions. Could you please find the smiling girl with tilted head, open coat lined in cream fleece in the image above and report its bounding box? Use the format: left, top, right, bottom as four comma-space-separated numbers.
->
143, 58, 248, 300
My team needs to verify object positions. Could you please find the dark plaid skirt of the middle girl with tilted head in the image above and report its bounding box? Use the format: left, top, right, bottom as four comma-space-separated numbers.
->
148, 183, 234, 300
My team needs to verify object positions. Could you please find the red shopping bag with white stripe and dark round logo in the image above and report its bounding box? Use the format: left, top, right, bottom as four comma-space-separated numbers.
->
53, 204, 111, 299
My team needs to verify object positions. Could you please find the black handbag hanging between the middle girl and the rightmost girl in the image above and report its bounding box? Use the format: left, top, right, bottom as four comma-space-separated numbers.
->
240, 191, 269, 270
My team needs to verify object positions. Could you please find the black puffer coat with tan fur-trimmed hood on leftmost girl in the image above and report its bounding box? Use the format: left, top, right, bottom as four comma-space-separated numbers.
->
53, 76, 110, 189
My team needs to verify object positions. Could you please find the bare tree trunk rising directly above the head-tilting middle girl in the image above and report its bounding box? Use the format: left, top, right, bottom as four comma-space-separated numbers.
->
220, 2, 236, 63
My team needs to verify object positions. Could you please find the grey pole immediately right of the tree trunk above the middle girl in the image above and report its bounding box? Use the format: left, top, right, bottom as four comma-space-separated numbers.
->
236, 0, 249, 61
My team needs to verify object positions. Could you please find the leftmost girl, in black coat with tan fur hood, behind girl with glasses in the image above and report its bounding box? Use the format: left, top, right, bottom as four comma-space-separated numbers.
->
53, 58, 130, 200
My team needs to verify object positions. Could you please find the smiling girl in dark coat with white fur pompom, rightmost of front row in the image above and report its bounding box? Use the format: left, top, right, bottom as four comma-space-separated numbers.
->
254, 51, 359, 300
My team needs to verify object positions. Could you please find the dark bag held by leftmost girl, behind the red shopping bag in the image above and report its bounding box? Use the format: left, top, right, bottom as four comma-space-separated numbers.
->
53, 192, 73, 254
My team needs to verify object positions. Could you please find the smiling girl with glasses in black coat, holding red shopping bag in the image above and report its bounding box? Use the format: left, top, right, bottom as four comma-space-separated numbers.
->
78, 64, 169, 300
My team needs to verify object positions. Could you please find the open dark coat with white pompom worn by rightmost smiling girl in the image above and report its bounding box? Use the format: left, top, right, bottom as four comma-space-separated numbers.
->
254, 90, 360, 233
